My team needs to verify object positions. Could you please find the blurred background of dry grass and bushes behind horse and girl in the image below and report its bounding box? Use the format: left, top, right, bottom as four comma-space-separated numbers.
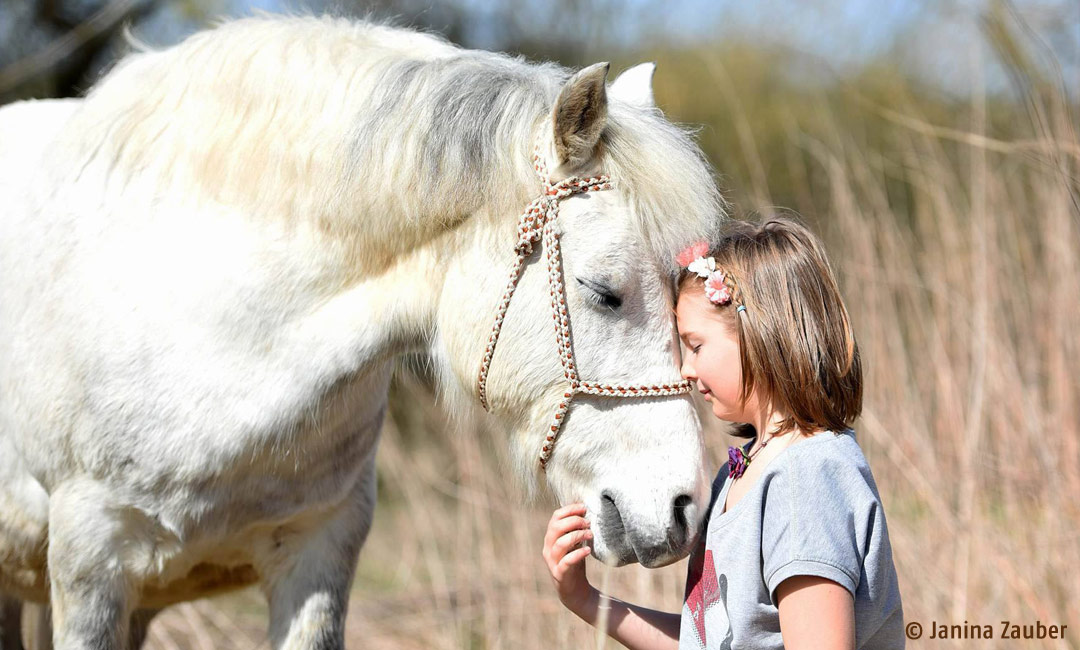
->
0, 0, 1080, 648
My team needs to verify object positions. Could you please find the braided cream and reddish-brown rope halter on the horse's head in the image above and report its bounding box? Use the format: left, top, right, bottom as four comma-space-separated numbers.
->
477, 144, 691, 470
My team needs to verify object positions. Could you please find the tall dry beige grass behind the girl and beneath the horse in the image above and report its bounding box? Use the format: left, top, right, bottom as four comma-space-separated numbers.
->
139, 6, 1080, 650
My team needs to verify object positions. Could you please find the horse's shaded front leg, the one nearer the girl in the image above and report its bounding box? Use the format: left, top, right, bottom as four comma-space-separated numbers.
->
265, 453, 375, 650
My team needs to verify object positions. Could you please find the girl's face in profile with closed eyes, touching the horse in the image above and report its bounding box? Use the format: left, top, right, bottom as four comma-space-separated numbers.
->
675, 289, 756, 422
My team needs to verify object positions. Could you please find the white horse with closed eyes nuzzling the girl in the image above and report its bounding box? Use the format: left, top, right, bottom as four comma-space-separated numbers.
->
0, 18, 723, 650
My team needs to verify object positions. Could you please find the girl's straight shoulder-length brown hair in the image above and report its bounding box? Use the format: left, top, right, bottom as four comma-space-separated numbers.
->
678, 217, 863, 437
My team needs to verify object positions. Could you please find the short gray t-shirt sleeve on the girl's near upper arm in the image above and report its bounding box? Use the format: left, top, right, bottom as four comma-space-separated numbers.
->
761, 453, 880, 606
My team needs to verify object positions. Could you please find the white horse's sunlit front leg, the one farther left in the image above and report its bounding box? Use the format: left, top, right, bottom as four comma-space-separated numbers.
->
49, 479, 141, 650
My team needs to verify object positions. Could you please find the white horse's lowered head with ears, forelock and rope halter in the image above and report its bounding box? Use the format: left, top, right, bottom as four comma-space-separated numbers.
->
440, 64, 721, 567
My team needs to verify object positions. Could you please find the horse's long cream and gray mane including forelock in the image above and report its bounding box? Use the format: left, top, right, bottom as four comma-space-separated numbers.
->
70, 16, 725, 270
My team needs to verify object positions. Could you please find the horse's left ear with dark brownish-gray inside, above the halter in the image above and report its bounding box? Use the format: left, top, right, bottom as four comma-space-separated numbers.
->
552, 63, 610, 167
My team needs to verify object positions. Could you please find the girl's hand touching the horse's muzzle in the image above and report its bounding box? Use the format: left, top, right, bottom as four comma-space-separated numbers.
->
543, 503, 593, 612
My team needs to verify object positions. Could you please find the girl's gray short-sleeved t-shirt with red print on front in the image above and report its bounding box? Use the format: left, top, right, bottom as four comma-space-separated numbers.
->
679, 430, 905, 650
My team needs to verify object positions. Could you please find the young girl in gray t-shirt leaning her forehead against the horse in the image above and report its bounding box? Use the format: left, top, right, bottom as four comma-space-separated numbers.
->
543, 219, 904, 650
